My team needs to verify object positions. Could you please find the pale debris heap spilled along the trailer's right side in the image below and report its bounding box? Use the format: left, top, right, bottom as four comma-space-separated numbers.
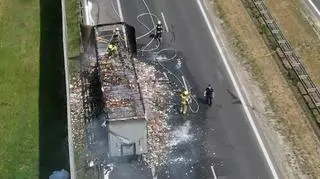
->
135, 60, 174, 166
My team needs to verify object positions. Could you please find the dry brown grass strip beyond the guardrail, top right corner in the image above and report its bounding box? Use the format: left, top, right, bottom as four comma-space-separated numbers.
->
266, 0, 320, 85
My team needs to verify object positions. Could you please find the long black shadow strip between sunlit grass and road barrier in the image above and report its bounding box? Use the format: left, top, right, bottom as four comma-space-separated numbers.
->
39, 0, 69, 179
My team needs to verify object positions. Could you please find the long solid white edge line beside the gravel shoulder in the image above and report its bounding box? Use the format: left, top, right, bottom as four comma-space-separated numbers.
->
197, 0, 279, 179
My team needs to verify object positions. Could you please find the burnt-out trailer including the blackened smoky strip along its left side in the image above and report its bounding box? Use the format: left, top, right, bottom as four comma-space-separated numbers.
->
81, 23, 147, 166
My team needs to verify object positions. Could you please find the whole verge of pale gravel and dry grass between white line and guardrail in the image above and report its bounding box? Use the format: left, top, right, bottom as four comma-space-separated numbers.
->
207, 1, 319, 178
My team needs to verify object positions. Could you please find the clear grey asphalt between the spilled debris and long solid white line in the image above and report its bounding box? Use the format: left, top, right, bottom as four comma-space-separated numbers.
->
121, 0, 272, 179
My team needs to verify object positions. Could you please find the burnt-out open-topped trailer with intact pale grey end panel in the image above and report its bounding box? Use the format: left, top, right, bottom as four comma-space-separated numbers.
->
94, 23, 147, 162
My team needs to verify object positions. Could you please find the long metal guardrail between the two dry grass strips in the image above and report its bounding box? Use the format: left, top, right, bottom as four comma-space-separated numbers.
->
251, 0, 320, 122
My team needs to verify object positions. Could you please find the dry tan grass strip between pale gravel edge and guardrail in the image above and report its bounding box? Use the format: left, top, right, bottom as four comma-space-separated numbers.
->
213, 0, 320, 179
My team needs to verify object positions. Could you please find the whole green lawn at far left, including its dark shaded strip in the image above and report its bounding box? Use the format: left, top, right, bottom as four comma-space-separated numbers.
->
0, 0, 72, 179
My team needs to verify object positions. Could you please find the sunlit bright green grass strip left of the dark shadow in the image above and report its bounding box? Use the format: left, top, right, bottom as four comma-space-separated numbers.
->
0, 0, 40, 179
